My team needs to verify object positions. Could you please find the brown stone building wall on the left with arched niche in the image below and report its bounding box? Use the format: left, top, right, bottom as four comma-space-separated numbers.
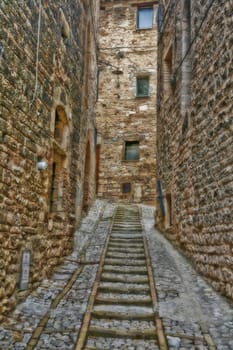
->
0, 0, 99, 314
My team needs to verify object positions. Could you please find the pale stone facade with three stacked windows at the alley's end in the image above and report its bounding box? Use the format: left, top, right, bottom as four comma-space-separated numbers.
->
97, 0, 157, 203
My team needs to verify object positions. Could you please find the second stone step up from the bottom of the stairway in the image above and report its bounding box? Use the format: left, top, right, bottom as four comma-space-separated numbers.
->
92, 305, 155, 321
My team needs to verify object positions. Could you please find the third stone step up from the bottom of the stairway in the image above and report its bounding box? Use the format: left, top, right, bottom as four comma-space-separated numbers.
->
95, 294, 152, 306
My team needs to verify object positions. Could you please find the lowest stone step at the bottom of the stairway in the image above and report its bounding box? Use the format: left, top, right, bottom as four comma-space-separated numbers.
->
88, 326, 156, 339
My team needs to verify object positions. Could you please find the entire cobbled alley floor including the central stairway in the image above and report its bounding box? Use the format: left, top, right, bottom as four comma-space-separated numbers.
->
0, 200, 233, 350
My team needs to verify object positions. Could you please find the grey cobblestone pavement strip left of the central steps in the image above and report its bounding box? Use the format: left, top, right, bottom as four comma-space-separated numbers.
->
0, 200, 115, 350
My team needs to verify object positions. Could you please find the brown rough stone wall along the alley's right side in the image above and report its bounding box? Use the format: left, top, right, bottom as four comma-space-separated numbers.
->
156, 0, 233, 298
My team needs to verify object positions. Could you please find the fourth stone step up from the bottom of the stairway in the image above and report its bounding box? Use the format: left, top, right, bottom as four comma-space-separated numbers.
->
98, 282, 150, 295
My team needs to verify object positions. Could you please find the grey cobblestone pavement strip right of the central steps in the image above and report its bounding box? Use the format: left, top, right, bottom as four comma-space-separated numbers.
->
142, 206, 233, 350
